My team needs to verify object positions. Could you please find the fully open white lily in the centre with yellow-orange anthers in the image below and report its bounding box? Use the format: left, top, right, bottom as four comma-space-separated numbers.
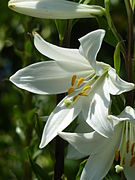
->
10, 29, 134, 147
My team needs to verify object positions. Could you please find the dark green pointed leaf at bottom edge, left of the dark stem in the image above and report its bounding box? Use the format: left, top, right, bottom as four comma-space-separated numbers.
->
29, 155, 50, 180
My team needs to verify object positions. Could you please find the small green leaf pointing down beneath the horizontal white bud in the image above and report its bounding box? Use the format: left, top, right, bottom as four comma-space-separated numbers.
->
55, 19, 67, 41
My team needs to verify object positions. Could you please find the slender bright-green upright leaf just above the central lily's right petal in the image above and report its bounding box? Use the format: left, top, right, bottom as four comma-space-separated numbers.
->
114, 42, 121, 74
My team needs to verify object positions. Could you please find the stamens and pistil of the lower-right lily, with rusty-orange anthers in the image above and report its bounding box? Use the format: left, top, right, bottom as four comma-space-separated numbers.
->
115, 122, 135, 173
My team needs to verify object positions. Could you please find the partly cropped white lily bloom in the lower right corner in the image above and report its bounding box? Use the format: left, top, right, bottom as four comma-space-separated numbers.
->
59, 106, 135, 180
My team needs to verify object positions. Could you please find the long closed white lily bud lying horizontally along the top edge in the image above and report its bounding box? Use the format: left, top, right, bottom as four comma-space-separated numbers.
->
8, 0, 105, 19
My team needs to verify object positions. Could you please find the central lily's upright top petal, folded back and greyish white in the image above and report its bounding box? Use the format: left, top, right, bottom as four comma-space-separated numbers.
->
79, 29, 105, 74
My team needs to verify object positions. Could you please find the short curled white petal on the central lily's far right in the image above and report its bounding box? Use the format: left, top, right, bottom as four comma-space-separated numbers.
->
108, 68, 135, 95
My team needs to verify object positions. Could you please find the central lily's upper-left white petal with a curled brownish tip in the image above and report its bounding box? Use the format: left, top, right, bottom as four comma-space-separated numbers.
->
34, 33, 92, 73
